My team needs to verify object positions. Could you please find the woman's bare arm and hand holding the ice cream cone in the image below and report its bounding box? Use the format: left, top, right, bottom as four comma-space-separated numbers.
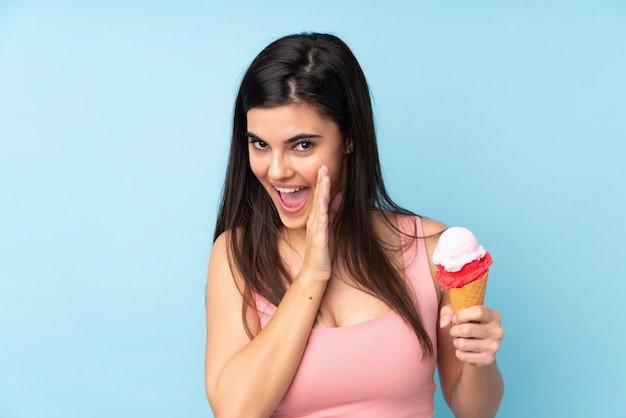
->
423, 220, 504, 418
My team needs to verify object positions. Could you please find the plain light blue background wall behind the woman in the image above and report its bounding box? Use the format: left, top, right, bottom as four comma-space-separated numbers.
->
0, 0, 626, 418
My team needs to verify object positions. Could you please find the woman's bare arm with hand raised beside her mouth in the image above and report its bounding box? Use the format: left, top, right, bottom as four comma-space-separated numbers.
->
205, 170, 340, 418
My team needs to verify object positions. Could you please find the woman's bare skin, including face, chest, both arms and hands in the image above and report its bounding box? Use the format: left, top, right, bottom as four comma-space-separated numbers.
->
205, 104, 504, 418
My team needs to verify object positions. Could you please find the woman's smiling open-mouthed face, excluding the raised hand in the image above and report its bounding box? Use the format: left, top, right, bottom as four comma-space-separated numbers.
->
246, 103, 348, 229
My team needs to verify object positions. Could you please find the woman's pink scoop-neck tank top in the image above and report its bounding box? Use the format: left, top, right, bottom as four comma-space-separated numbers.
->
255, 215, 438, 418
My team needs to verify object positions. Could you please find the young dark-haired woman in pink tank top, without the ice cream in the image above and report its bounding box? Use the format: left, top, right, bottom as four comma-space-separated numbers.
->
205, 34, 504, 418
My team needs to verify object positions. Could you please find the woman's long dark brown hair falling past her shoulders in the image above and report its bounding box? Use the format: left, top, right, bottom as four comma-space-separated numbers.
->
214, 33, 434, 355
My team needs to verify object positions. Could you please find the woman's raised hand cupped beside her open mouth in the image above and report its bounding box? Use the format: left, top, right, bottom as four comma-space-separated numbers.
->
302, 166, 342, 281
